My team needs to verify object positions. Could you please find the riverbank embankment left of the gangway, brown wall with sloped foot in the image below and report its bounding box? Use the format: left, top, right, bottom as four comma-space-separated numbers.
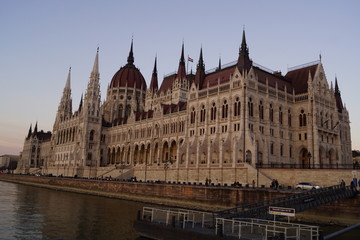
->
0, 174, 293, 211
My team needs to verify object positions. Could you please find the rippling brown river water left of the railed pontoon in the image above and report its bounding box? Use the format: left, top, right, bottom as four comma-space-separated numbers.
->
0, 182, 148, 239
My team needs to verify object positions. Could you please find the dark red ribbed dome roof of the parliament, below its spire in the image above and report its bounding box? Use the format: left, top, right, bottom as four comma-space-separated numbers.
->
110, 64, 146, 91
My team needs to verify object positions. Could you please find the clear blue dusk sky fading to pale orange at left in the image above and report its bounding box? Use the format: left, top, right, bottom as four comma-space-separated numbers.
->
0, 0, 360, 155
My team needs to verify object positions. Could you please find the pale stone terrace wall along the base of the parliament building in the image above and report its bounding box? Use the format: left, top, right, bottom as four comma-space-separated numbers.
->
37, 163, 360, 187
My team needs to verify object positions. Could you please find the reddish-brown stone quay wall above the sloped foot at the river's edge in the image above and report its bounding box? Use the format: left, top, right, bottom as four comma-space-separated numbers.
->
0, 175, 292, 207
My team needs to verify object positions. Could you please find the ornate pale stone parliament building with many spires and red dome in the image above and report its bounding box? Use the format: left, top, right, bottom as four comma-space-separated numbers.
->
18, 32, 352, 183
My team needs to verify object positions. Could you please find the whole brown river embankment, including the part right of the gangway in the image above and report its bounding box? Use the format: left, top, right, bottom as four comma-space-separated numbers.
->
0, 174, 360, 225
